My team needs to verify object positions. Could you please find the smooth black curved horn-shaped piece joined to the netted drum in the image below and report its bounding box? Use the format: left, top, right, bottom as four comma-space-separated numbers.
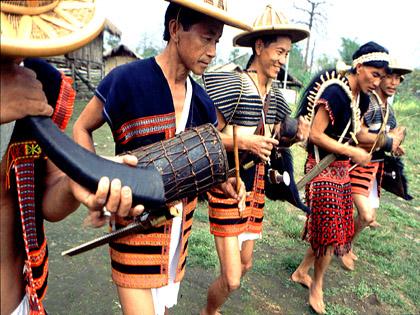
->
24, 116, 166, 208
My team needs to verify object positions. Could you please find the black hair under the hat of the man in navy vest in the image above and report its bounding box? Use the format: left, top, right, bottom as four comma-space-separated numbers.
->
163, 2, 213, 42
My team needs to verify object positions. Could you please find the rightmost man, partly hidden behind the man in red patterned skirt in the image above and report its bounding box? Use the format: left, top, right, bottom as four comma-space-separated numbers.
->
342, 59, 412, 270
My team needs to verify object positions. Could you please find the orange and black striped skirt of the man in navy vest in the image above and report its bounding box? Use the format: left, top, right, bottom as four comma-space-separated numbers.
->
110, 198, 197, 289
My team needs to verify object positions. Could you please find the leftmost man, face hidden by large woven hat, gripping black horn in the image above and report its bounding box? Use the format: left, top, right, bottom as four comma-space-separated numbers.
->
0, 0, 142, 315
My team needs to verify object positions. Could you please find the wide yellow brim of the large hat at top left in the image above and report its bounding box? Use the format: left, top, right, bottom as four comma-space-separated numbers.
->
0, 0, 105, 57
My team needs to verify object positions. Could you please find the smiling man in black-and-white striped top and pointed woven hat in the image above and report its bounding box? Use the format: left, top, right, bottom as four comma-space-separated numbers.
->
201, 6, 309, 315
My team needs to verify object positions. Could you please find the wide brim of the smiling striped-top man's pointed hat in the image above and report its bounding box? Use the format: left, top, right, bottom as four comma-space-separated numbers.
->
233, 24, 310, 47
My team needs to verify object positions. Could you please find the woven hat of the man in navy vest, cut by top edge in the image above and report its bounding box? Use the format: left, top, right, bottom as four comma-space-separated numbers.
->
166, 0, 252, 31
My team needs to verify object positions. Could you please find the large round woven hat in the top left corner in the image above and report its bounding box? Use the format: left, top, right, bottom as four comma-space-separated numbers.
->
1, 0, 105, 57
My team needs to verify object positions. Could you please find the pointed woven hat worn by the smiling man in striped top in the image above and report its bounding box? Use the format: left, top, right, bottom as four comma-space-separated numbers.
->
233, 5, 310, 47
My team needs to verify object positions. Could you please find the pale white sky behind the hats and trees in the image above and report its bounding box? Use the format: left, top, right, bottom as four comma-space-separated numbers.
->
101, 0, 420, 68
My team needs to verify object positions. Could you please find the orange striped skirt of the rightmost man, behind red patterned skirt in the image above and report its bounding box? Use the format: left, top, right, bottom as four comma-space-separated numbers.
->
350, 161, 384, 197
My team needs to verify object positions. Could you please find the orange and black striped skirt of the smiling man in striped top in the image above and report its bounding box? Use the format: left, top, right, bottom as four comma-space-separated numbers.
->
207, 163, 265, 236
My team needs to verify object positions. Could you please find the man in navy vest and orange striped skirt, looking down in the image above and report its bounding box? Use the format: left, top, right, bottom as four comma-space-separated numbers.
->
74, 0, 249, 314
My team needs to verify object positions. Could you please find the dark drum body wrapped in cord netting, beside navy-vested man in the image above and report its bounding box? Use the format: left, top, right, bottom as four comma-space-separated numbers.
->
127, 124, 229, 202
